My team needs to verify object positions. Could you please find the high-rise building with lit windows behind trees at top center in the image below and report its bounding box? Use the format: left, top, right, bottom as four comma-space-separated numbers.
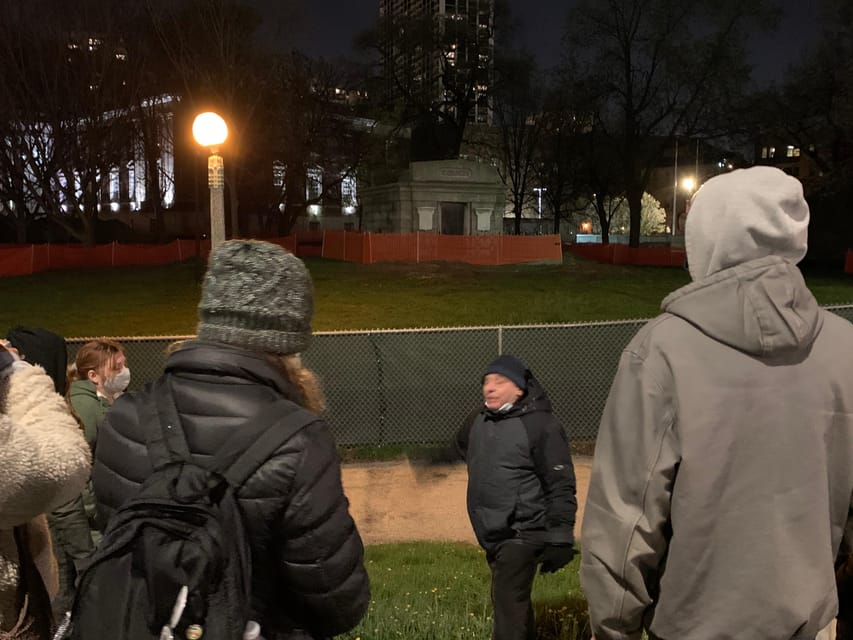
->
379, 0, 495, 123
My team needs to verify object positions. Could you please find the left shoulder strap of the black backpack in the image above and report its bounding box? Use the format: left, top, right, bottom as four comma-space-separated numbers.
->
142, 376, 191, 469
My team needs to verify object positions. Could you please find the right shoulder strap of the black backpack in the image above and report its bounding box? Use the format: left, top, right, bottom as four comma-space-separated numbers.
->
210, 399, 319, 489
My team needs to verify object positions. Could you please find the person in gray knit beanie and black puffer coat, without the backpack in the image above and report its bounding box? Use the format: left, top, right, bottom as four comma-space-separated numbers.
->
93, 240, 370, 640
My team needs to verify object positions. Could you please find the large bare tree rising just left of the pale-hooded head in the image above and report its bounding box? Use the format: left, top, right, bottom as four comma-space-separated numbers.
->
567, 0, 773, 246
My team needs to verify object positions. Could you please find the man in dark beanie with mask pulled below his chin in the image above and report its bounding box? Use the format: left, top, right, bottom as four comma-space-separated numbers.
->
456, 355, 577, 640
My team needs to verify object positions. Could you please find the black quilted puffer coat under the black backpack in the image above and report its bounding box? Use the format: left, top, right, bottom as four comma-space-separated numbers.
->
93, 341, 370, 640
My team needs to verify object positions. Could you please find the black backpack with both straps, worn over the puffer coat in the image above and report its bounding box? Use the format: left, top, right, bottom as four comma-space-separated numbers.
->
57, 376, 317, 640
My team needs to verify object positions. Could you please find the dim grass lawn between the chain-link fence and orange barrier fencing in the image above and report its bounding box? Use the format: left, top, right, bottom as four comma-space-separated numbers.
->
0, 255, 853, 337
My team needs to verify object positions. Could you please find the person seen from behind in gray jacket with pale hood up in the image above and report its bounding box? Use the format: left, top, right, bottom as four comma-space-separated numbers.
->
581, 167, 853, 640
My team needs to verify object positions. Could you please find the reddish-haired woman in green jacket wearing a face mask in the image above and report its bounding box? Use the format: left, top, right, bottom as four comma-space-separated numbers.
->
48, 338, 130, 615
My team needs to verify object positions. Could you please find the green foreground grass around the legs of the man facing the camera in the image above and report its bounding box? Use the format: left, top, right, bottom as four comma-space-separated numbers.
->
338, 542, 590, 640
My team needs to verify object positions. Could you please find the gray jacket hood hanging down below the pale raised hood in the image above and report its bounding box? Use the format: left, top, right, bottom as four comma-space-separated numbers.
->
661, 256, 823, 357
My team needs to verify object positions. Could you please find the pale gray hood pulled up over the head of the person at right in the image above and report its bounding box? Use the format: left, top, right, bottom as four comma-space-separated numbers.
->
684, 166, 809, 282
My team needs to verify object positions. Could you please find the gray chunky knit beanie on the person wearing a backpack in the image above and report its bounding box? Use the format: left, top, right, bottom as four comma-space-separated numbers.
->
198, 240, 314, 354
